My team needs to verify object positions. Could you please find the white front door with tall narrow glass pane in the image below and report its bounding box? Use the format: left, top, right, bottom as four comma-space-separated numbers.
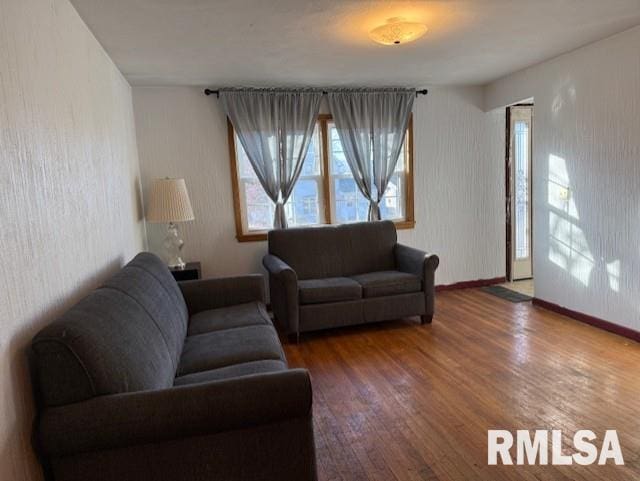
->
509, 106, 533, 281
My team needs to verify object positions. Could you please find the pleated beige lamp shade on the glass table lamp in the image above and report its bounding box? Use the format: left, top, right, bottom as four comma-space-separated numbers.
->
147, 179, 195, 223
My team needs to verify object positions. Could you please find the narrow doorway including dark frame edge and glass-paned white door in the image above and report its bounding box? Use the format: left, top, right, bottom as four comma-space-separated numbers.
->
506, 104, 533, 284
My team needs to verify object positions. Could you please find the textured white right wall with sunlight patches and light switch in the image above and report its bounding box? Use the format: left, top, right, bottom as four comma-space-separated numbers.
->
485, 27, 640, 330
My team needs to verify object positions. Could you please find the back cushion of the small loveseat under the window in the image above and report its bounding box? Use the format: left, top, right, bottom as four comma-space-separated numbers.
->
269, 221, 397, 279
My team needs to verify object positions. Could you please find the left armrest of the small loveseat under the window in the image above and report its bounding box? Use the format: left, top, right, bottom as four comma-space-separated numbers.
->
262, 254, 300, 336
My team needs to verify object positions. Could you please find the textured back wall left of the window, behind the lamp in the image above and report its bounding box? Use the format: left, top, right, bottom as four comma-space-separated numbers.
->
133, 87, 266, 277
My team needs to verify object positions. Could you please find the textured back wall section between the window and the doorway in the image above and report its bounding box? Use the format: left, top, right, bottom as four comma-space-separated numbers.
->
398, 87, 506, 284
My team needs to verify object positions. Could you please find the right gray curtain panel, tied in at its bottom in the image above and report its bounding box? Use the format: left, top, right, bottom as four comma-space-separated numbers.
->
328, 89, 416, 220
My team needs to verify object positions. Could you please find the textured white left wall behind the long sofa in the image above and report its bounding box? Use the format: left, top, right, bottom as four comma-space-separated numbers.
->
0, 0, 144, 481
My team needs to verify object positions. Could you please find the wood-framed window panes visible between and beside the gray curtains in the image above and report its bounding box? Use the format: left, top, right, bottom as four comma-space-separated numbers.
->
228, 115, 414, 241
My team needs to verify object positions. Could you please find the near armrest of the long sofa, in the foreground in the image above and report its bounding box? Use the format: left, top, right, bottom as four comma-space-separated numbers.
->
39, 369, 312, 457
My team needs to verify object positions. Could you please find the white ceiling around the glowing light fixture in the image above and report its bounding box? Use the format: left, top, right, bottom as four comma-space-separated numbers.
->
71, 0, 640, 87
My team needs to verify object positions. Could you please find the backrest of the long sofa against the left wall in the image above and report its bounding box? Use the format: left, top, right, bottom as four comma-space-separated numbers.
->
32, 253, 187, 406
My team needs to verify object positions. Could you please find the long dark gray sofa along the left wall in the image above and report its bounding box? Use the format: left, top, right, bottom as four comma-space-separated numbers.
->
32, 253, 316, 481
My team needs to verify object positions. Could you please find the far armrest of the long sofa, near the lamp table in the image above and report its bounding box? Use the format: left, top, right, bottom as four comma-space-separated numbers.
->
178, 274, 266, 316
